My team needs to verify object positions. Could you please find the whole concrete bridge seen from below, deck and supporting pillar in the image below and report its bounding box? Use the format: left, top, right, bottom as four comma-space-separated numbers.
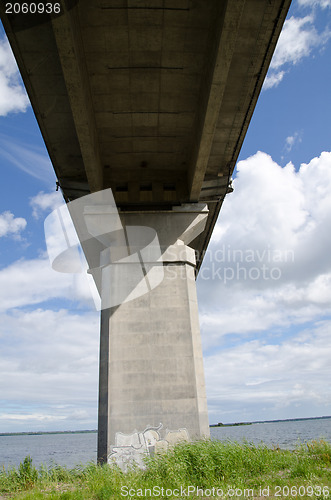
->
0, 0, 290, 464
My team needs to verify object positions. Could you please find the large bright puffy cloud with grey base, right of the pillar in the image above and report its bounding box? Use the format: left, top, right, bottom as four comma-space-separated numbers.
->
198, 152, 331, 348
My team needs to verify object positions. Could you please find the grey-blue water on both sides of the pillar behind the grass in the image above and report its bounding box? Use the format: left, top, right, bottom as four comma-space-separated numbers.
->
0, 418, 331, 468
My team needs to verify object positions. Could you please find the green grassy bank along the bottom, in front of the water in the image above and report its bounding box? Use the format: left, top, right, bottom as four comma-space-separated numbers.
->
0, 441, 331, 500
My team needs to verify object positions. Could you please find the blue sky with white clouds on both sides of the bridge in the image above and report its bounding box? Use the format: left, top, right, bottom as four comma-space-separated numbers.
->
0, 0, 331, 432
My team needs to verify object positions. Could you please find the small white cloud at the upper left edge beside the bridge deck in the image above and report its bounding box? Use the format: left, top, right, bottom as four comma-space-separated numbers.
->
0, 39, 29, 116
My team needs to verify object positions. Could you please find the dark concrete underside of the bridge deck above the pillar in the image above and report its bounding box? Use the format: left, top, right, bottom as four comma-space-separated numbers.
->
0, 0, 290, 267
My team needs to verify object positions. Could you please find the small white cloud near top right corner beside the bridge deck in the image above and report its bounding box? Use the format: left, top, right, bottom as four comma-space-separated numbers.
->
263, 12, 331, 89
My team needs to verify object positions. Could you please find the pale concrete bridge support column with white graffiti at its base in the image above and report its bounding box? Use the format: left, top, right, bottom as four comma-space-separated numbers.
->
98, 204, 209, 469
